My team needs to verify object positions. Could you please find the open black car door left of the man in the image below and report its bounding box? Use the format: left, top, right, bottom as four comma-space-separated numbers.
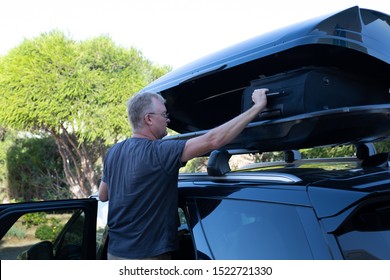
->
0, 198, 97, 260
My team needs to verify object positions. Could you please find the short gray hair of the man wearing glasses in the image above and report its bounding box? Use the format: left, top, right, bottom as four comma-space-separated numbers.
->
127, 92, 165, 131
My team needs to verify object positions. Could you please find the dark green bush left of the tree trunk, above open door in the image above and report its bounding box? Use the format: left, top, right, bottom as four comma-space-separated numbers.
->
6, 132, 71, 201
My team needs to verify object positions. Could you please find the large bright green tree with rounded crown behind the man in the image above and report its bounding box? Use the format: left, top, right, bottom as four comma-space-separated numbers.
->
0, 31, 170, 197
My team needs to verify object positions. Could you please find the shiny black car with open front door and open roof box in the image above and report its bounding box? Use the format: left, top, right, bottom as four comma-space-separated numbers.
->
0, 4, 390, 260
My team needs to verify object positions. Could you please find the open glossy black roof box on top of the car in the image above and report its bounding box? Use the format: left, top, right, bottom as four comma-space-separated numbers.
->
143, 6, 390, 151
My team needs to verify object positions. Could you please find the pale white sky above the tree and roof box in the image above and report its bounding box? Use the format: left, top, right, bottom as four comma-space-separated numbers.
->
0, 0, 390, 68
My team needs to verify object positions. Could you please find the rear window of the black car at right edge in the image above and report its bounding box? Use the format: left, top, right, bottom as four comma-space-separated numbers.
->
336, 201, 390, 260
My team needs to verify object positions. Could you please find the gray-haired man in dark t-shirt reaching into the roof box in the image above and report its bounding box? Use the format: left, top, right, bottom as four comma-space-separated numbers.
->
99, 89, 268, 259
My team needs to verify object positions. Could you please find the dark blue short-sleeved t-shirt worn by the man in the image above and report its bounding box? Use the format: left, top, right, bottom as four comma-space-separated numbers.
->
102, 138, 185, 259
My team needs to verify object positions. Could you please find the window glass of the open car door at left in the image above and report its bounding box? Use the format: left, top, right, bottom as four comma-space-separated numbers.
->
0, 211, 75, 260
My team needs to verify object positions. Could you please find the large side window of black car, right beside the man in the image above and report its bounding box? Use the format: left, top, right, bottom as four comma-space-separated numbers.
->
194, 199, 313, 259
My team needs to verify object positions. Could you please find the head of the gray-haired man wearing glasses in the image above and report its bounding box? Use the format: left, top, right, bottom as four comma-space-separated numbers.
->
127, 92, 169, 139
